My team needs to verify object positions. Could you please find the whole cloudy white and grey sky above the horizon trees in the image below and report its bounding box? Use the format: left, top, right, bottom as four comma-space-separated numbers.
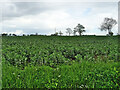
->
0, 2, 118, 35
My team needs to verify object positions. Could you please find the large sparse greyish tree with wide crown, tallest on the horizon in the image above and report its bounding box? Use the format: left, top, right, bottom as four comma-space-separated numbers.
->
100, 17, 117, 36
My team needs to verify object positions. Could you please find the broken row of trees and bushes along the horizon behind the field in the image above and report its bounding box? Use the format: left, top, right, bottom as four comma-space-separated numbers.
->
2, 17, 119, 36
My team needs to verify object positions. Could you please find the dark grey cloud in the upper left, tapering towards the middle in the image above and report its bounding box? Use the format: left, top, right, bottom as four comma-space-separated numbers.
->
2, 2, 62, 20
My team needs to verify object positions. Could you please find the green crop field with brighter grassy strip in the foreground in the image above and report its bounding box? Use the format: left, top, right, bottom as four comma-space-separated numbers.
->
2, 36, 120, 88
